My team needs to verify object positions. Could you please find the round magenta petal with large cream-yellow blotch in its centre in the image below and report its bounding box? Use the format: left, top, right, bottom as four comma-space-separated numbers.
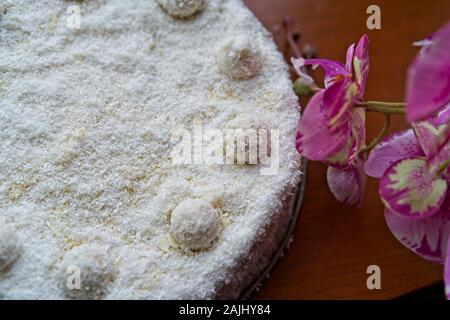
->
380, 157, 447, 218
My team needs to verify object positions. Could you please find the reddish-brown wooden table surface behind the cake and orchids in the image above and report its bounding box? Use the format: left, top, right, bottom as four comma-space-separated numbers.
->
245, 0, 450, 299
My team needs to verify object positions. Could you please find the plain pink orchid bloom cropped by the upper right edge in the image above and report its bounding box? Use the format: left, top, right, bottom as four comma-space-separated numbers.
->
406, 22, 450, 122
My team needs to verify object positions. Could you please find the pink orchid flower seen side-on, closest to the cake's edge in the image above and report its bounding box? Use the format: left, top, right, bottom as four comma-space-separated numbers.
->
292, 35, 369, 204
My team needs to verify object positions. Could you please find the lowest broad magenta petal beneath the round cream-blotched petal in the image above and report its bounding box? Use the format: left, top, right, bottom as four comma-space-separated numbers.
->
384, 197, 450, 263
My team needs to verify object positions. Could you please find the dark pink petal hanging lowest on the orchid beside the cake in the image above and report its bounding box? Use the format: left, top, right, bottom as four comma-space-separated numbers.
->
327, 159, 367, 206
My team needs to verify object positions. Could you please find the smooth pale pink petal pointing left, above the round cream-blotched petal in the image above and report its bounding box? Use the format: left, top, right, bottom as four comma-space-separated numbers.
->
364, 129, 424, 178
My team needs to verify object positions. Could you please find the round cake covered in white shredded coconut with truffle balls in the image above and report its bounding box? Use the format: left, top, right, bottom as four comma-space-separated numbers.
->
0, 0, 301, 299
